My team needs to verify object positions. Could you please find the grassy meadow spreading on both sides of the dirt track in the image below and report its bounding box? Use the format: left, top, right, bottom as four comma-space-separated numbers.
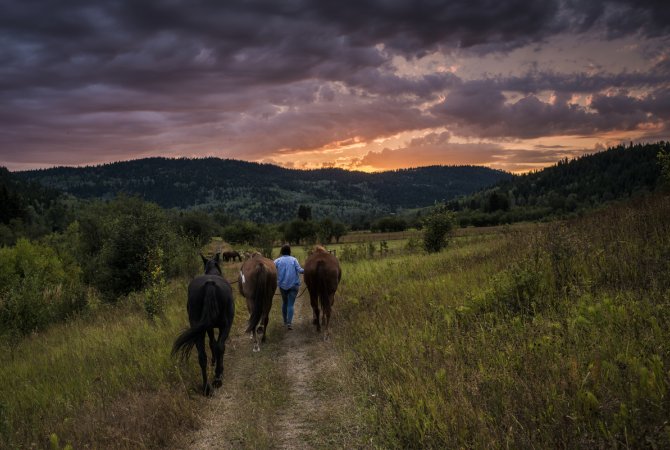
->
0, 196, 670, 448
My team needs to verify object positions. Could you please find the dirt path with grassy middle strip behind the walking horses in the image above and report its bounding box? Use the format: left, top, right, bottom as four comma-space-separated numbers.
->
184, 294, 360, 449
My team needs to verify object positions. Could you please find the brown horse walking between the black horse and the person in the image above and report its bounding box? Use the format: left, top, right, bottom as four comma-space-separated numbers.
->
238, 253, 277, 352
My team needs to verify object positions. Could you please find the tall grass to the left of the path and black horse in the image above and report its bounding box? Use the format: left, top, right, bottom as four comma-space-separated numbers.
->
0, 283, 207, 448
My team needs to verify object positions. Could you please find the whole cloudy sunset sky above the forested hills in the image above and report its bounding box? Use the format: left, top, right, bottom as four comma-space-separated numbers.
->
0, 0, 670, 173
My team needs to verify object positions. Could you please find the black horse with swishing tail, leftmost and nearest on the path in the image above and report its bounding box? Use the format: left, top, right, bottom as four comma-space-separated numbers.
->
172, 253, 235, 396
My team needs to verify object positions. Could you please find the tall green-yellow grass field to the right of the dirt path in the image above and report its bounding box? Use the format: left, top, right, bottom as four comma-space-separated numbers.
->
338, 197, 670, 448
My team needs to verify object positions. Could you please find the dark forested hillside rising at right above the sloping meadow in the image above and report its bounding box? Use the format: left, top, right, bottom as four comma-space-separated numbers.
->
448, 142, 670, 225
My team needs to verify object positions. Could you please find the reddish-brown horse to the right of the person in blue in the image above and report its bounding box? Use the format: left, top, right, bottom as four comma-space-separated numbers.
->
304, 246, 342, 340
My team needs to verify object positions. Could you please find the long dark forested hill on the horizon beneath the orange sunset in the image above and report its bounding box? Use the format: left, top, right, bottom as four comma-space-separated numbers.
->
16, 158, 510, 222
